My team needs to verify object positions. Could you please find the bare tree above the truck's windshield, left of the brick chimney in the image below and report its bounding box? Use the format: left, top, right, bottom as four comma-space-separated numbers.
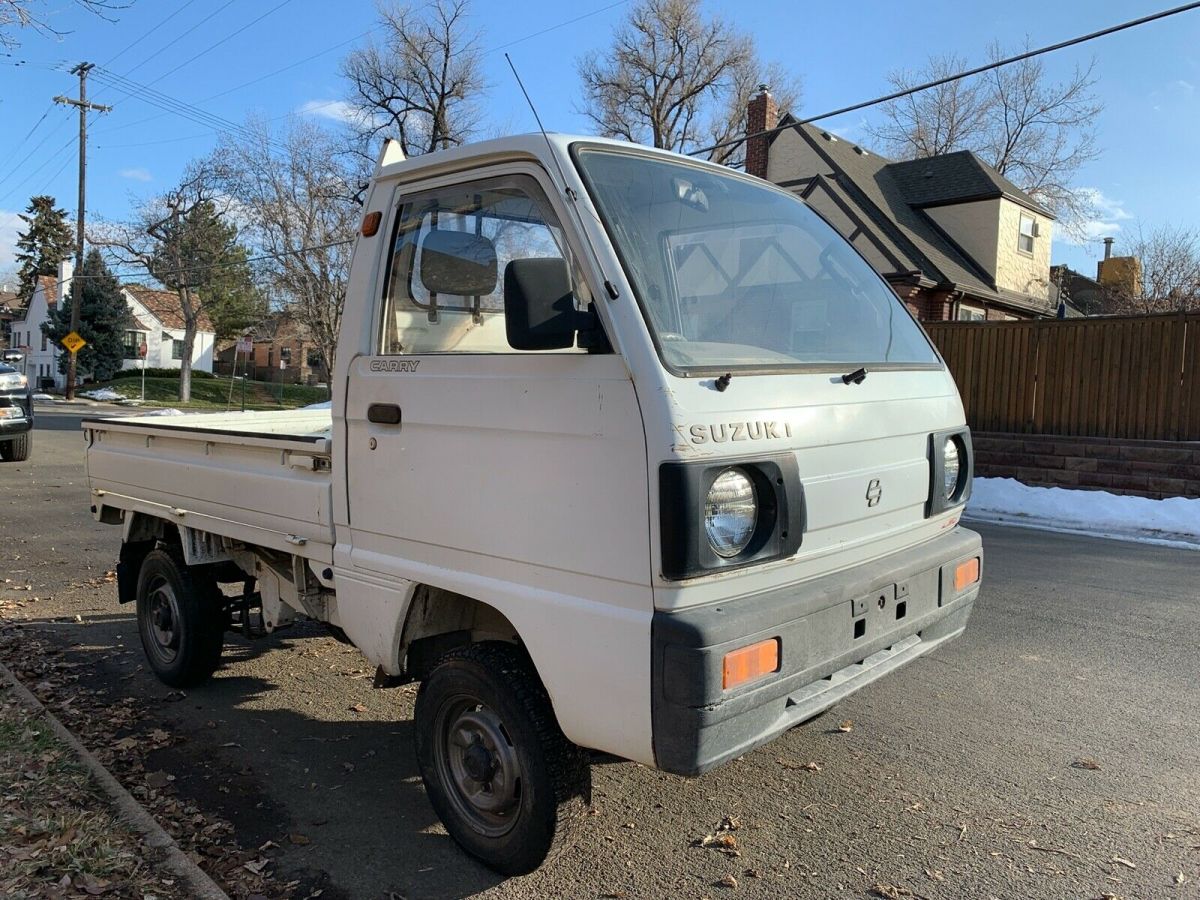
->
578, 0, 799, 164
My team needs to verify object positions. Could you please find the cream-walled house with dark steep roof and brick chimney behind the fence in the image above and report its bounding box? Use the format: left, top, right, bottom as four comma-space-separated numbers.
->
746, 88, 1057, 322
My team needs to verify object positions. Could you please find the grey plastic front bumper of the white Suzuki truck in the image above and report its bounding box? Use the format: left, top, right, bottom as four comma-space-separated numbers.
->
652, 528, 983, 775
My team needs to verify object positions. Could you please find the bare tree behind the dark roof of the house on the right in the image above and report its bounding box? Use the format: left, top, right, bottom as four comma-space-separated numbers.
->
872, 44, 1103, 230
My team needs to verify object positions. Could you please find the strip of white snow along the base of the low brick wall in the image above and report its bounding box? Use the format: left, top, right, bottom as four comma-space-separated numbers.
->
966, 478, 1200, 550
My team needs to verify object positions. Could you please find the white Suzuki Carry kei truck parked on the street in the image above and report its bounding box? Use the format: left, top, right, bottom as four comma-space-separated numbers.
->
83, 133, 983, 874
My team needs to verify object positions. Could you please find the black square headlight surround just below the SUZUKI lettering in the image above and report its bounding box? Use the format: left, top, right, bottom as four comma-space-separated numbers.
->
659, 454, 805, 581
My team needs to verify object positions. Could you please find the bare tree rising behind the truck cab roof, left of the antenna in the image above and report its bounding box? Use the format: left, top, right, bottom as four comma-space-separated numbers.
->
342, 0, 486, 156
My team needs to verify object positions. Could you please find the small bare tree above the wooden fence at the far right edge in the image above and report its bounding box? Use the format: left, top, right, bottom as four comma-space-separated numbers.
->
1105, 226, 1200, 316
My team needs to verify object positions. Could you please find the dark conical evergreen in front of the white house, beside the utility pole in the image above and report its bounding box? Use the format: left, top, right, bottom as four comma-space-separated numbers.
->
43, 250, 134, 382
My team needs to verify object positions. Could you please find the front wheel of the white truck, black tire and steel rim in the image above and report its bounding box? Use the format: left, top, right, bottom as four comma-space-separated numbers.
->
414, 642, 592, 875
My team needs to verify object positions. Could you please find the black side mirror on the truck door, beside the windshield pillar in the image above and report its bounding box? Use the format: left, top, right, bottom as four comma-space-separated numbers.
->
504, 259, 595, 350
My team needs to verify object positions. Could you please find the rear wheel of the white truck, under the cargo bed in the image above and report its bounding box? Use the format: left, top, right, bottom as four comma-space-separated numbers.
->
138, 548, 226, 688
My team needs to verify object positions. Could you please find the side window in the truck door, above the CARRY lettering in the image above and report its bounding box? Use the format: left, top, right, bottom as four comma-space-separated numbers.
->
379, 175, 592, 355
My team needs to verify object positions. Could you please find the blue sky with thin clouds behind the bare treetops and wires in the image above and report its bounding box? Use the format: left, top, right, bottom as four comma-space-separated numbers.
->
0, 0, 1200, 282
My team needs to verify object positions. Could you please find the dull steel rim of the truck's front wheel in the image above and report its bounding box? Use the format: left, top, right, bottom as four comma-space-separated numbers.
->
434, 696, 524, 838
